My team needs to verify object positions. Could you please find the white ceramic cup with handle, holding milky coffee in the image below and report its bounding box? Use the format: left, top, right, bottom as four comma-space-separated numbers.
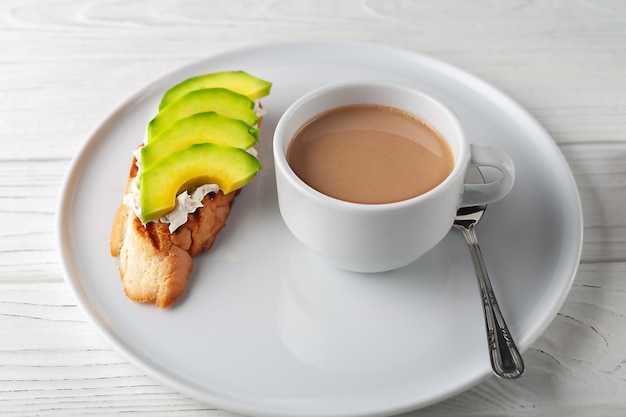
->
273, 82, 515, 272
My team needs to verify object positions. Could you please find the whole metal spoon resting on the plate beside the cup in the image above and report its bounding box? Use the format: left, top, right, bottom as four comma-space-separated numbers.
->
454, 167, 524, 379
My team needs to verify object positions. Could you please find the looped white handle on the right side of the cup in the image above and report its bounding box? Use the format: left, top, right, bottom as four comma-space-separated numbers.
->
461, 144, 515, 207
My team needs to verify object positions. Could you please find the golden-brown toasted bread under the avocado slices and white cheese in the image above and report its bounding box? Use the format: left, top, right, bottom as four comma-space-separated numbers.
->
109, 159, 239, 307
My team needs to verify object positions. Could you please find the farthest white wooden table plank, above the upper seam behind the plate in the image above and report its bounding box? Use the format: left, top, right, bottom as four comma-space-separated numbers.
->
0, 0, 626, 160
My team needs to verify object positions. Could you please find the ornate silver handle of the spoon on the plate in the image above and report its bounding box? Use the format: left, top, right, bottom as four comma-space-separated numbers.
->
462, 225, 524, 379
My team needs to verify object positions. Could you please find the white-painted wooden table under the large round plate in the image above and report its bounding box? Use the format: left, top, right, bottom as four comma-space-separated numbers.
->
0, 0, 626, 417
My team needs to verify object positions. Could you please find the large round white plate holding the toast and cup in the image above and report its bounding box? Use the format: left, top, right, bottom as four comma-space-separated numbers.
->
58, 43, 582, 416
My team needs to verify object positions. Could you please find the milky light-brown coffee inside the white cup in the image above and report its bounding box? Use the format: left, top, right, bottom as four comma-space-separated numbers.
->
287, 104, 454, 204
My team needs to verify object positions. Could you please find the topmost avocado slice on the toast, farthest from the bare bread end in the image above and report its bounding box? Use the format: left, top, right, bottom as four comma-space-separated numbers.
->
159, 71, 272, 110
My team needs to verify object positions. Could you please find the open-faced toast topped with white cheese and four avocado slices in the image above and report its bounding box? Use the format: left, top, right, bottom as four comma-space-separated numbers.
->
110, 71, 271, 307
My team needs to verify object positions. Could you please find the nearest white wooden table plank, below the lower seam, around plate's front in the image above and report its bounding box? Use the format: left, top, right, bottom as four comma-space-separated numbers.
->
0, 263, 626, 417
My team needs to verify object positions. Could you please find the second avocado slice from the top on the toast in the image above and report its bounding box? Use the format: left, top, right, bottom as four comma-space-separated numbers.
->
148, 88, 259, 143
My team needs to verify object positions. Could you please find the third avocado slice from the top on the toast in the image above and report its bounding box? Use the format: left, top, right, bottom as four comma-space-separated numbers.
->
141, 112, 259, 170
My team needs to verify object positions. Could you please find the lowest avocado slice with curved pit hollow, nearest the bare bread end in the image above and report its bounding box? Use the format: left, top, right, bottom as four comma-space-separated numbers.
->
139, 143, 261, 223
